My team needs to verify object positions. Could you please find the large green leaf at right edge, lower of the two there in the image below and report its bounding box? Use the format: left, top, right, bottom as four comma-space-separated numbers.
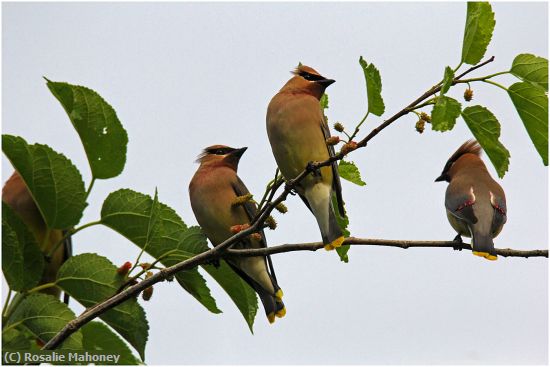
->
508, 82, 548, 166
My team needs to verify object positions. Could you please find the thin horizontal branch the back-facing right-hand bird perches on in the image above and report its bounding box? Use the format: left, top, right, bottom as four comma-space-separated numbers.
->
225, 237, 548, 258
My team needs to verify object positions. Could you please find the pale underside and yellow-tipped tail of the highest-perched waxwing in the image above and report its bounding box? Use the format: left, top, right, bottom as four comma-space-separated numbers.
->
305, 183, 344, 251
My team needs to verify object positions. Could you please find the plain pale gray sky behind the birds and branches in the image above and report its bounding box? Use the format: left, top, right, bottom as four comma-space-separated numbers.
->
2, 2, 548, 364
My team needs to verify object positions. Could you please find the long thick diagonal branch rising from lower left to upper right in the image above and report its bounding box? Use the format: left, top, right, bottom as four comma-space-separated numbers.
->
42, 57, 505, 350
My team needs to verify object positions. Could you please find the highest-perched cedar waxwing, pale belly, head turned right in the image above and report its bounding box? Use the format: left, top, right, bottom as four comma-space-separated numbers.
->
266, 65, 345, 250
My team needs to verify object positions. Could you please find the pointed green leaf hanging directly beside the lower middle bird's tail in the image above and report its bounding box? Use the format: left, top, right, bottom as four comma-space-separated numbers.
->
203, 260, 258, 333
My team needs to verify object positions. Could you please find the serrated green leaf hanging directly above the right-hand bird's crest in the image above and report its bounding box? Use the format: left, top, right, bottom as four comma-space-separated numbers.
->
462, 106, 510, 178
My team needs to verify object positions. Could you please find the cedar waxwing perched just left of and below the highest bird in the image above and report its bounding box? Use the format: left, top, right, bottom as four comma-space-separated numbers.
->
189, 145, 286, 323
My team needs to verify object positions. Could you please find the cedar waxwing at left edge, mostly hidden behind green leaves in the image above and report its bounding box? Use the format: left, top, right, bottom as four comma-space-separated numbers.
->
2, 172, 72, 303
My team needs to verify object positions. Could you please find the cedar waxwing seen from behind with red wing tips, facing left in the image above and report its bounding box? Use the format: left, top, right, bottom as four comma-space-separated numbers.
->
435, 140, 506, 260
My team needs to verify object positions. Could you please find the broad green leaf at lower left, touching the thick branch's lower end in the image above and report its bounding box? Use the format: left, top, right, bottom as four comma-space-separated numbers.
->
4, 293, 82, 350
